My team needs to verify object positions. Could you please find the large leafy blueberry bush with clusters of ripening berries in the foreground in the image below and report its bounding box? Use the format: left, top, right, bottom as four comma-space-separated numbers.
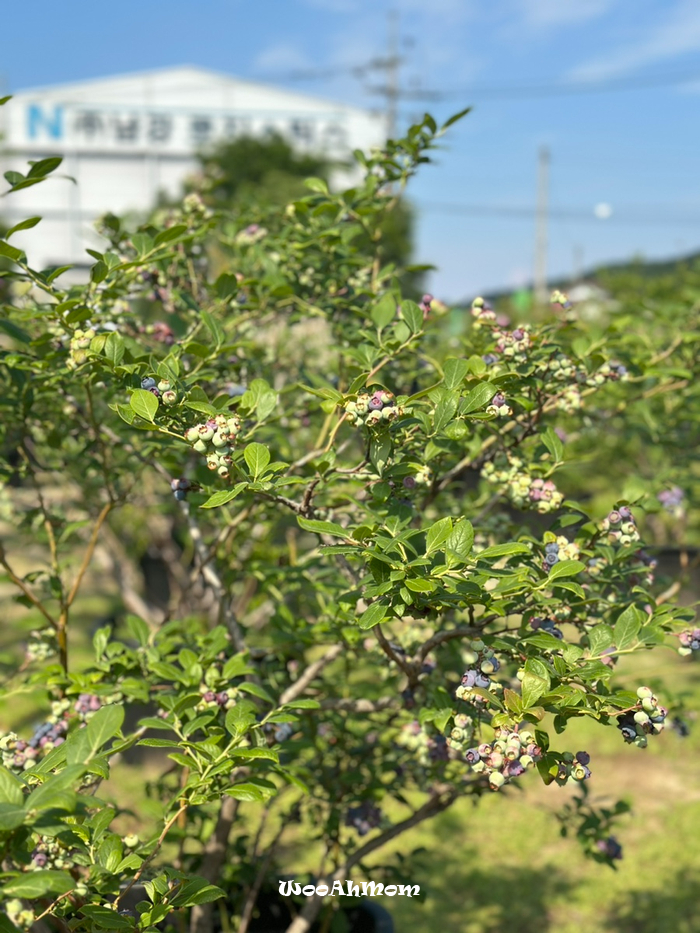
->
0, 98, 700, 933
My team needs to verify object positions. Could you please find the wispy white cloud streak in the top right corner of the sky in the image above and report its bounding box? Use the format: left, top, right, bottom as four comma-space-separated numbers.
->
569, 0, 700, 81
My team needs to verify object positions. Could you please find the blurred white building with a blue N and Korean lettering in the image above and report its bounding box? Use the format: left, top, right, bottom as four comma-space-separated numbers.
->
0, 67, 384, 269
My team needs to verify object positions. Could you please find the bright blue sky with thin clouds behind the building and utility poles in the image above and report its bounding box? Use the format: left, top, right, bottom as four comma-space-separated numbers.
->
0, 0, 700, 299
